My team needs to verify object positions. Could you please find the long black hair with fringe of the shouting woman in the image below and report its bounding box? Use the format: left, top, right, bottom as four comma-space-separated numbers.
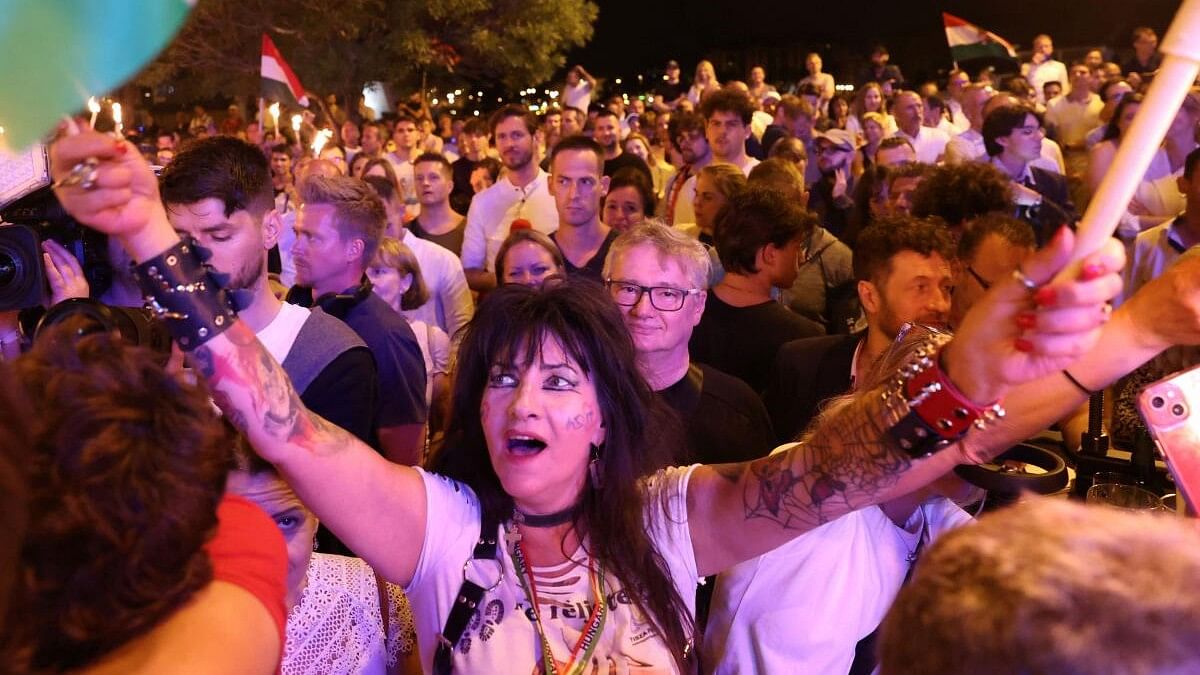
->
431, 280, 696, 670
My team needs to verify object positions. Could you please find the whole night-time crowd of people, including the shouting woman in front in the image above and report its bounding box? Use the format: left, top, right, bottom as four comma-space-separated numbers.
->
7, 23, 1200, 674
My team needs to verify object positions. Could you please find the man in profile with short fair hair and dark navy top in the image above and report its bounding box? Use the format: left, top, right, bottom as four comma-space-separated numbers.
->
288, 177, 427, 465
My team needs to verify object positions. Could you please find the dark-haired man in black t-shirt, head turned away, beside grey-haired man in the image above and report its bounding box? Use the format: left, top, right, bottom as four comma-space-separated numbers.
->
690, 186, 824, 392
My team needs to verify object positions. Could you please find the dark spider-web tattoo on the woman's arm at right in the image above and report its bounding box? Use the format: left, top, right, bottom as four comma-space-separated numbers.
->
739, 393, 912, 530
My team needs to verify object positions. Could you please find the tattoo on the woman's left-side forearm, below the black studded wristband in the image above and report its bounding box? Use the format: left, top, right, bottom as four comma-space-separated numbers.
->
192, 323, 352, 454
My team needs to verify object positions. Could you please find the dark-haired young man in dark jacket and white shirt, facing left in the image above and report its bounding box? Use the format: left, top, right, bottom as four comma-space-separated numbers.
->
983, 104, 1079, 246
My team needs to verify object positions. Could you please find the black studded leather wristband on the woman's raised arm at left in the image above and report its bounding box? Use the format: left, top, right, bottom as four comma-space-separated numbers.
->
134, 239, 238, 352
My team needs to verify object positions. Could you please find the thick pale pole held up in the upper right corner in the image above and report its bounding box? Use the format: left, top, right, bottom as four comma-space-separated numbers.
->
1063, 0, 1200, 265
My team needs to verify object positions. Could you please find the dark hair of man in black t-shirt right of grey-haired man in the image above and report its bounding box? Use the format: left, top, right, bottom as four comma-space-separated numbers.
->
713, 185, 817, 275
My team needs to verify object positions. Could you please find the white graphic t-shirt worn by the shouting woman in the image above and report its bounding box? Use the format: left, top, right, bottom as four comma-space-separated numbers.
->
406, 467, 697, 674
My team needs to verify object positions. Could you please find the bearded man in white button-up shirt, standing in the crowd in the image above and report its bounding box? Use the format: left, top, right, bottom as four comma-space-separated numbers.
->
462, 104, 558, 292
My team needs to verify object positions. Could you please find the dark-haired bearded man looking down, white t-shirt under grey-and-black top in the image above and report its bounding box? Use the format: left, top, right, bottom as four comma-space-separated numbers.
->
162, 137, 379, 441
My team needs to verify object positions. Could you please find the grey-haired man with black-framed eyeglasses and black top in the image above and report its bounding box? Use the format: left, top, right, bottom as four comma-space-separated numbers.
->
604, 221, 774, 464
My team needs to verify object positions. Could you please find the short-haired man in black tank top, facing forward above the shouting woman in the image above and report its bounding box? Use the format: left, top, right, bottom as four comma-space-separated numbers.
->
550, 136, 617, 281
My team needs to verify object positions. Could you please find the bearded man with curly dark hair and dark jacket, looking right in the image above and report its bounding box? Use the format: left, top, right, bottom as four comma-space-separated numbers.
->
763, 217, 954, 443
